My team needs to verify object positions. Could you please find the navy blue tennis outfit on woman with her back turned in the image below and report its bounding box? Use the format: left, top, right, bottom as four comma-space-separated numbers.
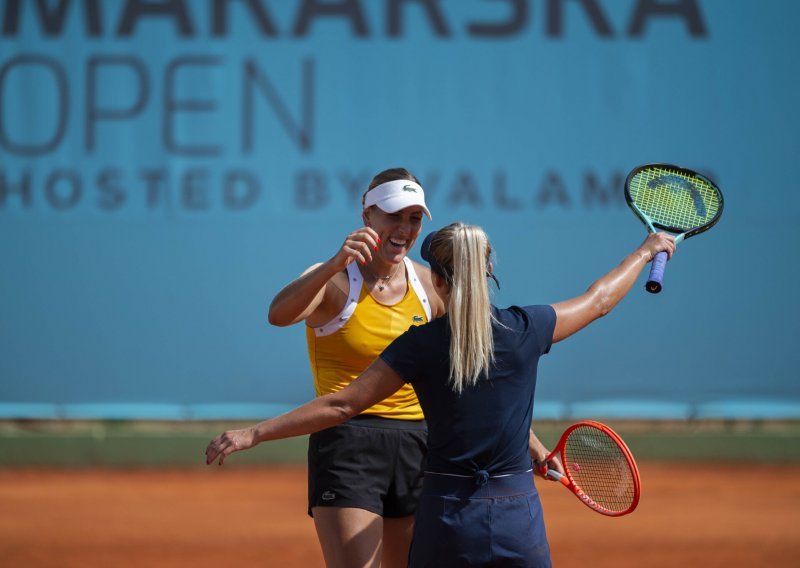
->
381, 306, 556, 567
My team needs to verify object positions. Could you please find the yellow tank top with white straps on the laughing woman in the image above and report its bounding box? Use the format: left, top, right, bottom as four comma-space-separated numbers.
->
306, 258, 430, 420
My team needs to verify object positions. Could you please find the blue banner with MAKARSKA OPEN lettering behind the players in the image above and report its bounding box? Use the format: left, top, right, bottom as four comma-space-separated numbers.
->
0, 0, 800, 418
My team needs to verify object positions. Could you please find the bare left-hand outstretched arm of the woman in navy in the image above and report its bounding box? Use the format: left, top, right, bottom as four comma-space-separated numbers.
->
206, 358, 405, 465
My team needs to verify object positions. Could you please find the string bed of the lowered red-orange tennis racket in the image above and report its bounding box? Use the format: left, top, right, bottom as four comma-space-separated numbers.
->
563, 426, 636, 513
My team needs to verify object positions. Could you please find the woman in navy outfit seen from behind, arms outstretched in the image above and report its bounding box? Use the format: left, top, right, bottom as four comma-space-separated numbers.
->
206, 223, 675, 567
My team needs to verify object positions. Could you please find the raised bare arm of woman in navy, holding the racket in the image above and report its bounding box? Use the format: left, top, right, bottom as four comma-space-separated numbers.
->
553, 233, 675, 343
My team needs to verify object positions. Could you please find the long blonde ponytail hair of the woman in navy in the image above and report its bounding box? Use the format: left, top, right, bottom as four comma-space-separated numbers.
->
430, 223, 494, 393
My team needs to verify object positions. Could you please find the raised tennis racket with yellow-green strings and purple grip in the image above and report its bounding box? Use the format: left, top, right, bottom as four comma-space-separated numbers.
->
625, 164, 723, 294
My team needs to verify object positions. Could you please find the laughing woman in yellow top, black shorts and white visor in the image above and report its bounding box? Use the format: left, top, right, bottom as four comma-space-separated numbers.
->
269, 168, 560, 568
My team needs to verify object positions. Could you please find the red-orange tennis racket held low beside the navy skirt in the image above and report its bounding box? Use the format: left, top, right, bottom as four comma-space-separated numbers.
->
541, 420, 640, 517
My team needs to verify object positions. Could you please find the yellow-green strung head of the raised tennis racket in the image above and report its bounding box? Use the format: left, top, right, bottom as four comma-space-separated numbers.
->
629, 168, 721, 231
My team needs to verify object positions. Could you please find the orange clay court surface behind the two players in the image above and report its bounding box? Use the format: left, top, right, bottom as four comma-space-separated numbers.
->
0, 460, 800, 568
